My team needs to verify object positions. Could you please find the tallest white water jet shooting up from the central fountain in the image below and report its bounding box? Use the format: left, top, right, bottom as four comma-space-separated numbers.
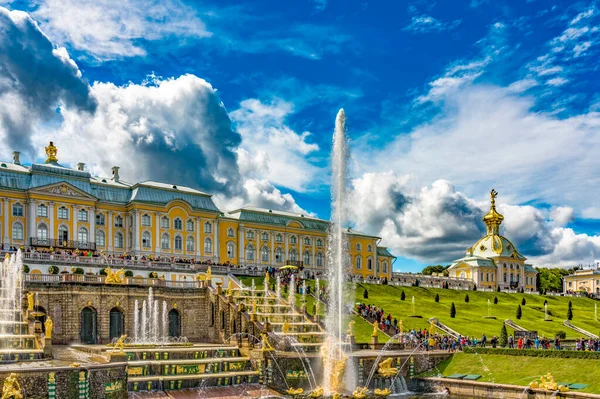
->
322, 109, 350, 393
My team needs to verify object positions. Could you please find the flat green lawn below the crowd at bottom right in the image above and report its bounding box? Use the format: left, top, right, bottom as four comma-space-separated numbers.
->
424, 353, 600, 393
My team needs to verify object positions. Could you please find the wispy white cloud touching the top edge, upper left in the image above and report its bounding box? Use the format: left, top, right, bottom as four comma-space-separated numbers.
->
33, 0, 211, 60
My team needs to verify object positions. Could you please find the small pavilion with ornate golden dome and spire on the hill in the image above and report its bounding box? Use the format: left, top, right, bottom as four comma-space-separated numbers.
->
448, 190, 537, 291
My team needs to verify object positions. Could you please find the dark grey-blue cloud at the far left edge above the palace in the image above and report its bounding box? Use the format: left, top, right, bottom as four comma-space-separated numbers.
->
0, 7, 96, 153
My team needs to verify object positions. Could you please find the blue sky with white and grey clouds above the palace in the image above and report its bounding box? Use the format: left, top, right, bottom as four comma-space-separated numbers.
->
0, 0, 600, 271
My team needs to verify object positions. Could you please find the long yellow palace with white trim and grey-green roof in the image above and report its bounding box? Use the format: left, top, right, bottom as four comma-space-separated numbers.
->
0, 142, 395, 279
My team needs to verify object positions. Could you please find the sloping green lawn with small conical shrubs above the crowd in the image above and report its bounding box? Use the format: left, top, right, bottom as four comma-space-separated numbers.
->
355, 284, 600, 339
